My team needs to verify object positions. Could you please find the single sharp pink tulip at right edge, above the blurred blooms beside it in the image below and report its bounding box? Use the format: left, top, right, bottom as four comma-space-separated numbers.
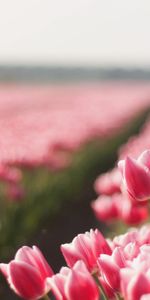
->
119, 157, 150, 201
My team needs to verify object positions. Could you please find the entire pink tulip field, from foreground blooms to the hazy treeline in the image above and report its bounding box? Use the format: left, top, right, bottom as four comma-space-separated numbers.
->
0, 81, 150, 300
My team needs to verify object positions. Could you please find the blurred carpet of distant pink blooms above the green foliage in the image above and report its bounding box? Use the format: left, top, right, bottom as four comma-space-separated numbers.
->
0, 83, 150, 198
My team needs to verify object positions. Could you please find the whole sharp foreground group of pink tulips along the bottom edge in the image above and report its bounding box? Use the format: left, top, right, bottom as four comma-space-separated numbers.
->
0, 225, 150, 300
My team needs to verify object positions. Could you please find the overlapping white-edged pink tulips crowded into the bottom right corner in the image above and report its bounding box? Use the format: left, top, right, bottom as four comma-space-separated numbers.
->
98, 225, 150, 300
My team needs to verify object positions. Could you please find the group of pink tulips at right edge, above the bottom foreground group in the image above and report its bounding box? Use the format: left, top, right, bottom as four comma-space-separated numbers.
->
92, 150, 150, 225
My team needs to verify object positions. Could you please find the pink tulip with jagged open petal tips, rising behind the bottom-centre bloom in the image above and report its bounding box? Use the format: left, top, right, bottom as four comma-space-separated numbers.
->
61, 229, 111, 272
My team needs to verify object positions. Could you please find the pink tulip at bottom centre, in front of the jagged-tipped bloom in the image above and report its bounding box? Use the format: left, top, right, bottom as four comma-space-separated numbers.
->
47, 261, 99, 300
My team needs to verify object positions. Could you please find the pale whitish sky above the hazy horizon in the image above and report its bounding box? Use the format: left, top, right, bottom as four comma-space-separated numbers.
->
0, 0, 150, 66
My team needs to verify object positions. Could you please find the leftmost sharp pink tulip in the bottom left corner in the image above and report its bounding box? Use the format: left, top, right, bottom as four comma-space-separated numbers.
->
0, 246, 53, 300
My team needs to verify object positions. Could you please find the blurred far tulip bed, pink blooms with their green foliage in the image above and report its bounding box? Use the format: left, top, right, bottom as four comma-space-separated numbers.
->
0, 83, 149, 259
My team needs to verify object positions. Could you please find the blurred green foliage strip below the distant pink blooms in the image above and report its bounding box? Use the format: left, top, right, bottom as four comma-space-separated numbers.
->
0, 117, 143, 259
